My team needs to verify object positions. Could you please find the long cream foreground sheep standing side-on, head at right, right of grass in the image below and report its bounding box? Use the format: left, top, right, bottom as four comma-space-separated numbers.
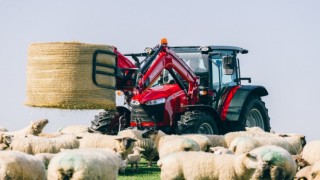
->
157, 151, 264, 180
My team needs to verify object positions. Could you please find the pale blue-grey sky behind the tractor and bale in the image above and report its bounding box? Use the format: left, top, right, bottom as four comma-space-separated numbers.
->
0, 0, 320, 140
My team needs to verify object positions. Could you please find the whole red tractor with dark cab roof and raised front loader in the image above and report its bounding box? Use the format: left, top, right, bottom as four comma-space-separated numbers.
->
90, 39, 270, 134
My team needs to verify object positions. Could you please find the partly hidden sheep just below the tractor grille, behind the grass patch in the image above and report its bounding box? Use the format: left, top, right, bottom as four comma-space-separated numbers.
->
118, 129, 158, 167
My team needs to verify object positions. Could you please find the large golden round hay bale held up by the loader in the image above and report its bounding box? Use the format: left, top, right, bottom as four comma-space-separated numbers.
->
25, 42, 116, 110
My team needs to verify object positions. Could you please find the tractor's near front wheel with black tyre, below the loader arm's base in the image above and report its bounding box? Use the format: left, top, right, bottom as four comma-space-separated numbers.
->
177, 110, 218, 134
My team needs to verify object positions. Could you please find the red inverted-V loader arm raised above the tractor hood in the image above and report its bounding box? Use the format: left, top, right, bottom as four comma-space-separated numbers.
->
137, 42, 199, 103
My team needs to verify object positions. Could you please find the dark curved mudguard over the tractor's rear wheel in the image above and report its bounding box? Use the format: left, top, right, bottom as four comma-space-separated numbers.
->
222, 85, 268, 121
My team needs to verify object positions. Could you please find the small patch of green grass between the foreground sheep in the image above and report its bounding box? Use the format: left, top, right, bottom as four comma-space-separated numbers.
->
118, 158, 160, 180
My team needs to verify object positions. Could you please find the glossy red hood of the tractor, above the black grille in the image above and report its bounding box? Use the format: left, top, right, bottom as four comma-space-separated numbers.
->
132, 84, 181, 104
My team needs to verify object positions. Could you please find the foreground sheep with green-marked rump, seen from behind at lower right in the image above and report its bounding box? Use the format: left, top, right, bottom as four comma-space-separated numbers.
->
249, 145, 297, 179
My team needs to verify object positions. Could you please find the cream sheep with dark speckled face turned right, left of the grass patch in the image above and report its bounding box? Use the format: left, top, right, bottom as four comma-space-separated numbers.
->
77, 133, 136, 160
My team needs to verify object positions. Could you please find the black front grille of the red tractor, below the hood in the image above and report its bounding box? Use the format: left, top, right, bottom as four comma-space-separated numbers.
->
131, 104, 164, 122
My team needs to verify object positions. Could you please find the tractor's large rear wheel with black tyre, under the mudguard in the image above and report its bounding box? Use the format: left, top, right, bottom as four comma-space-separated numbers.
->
231, 95, 270, 132
